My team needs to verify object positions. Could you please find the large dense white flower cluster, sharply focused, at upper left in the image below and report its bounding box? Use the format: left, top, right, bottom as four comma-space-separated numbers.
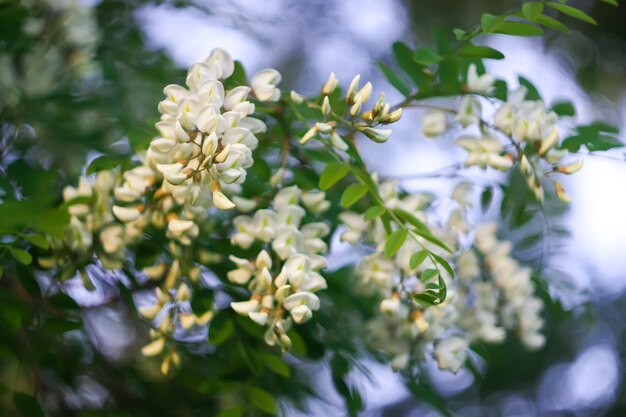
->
113, 49, 280, 245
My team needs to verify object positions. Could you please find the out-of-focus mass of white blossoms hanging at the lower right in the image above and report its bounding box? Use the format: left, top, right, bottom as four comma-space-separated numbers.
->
340, 183, 544, 372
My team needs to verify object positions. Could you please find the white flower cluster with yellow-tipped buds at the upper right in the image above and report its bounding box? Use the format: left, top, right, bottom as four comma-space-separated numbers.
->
444, 66, 582, 202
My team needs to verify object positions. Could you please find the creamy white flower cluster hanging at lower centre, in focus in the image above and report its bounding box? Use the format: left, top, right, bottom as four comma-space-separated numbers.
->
228, 186, 330, 351
